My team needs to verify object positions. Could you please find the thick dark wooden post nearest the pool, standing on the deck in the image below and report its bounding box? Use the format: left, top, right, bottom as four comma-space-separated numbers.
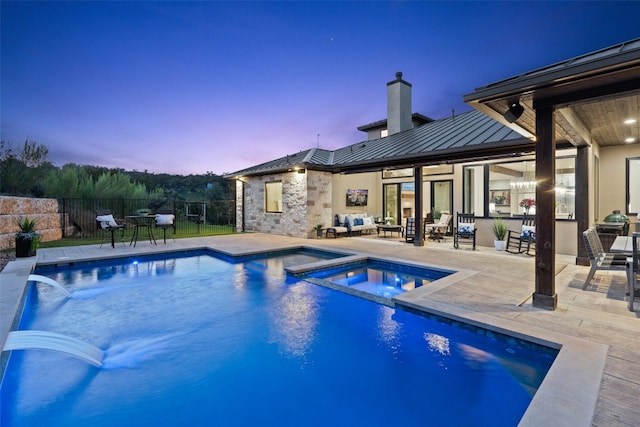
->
533, 107, 558, 310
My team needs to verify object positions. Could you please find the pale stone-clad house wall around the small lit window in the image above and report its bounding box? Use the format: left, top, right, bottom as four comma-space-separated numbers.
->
236, 171, 332, 238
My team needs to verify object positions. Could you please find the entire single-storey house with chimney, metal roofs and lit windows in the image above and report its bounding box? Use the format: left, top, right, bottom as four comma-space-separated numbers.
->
226, 39, 640, 280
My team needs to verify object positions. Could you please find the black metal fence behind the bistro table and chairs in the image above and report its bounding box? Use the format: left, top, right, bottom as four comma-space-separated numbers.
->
58, 198, 236, 238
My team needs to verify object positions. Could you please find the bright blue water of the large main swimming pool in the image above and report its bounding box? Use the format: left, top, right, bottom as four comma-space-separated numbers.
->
0, 252, 555, 427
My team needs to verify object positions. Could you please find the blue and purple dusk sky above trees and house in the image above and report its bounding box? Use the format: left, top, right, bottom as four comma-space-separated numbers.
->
0, 1, 640, 174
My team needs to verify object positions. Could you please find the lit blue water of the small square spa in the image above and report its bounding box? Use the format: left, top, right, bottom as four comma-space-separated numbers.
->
307, 260, 454, 298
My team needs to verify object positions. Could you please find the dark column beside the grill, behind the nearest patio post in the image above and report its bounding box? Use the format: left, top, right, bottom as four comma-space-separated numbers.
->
575, 145, 597, 265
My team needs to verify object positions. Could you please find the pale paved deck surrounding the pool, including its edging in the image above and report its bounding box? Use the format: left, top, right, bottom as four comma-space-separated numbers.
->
0, 233, 640, 427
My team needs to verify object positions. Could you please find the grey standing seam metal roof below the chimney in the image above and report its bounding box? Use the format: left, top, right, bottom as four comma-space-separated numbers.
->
225, 110, 534, 178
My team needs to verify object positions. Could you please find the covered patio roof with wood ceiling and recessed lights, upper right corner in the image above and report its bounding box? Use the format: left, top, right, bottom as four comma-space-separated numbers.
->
464, 39, 640, 150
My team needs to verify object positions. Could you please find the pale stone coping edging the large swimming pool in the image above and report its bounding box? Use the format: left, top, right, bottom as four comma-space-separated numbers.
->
0, 244, 609, 427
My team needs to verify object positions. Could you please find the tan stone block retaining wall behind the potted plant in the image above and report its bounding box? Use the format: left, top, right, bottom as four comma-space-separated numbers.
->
0, 196, 62, 250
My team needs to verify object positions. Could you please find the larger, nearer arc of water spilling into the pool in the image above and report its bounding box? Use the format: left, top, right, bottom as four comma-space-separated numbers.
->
2, 331, 104, 368
